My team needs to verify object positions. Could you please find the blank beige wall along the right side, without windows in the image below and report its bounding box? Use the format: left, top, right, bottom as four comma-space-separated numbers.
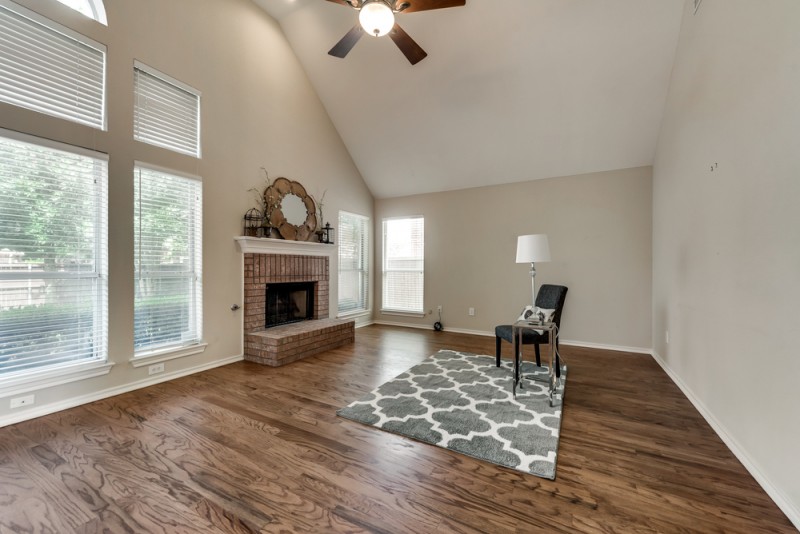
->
653, 0, 800, 527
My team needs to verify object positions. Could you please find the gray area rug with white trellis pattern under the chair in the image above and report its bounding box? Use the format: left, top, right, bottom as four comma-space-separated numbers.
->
336, 350, 566, 480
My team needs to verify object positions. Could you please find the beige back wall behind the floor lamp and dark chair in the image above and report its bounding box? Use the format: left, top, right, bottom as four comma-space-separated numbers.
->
374, 167, 652, 351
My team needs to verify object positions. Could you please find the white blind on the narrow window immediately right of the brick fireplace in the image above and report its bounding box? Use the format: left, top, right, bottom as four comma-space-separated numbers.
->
338, 211, 369, 314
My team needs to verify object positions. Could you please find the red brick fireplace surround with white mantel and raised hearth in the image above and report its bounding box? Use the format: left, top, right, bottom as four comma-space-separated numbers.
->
236, 237, 355, 367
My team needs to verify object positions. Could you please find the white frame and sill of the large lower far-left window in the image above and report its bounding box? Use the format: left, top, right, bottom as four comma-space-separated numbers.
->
0, 128, 114, 396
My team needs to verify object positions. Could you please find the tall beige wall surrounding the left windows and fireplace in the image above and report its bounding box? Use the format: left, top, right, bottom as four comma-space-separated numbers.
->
0, 0, 373, 424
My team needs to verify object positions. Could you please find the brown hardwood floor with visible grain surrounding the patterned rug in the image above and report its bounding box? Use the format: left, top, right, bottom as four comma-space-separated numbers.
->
0, 326, 796, 533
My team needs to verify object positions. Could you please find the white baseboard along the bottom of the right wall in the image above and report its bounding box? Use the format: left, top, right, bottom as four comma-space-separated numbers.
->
653, 350, 800, 530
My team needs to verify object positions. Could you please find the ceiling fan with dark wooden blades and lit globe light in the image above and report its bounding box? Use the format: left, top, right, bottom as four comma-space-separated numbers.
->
328, 0, 467, 65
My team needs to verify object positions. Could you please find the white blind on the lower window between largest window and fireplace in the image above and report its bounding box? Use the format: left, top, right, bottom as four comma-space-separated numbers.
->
134, 163, 203, 353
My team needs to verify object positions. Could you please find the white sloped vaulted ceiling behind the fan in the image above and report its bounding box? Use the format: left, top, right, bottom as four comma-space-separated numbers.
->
254, 0, 684, 198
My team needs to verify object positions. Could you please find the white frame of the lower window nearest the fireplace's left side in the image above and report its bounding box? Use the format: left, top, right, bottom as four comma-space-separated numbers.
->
131, 161, 207, 358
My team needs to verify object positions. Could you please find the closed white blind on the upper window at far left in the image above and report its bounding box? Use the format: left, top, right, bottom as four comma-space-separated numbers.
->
0, 0, 106, 129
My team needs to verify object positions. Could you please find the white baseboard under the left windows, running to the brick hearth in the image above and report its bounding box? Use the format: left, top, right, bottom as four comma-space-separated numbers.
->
0, 354, 244, 428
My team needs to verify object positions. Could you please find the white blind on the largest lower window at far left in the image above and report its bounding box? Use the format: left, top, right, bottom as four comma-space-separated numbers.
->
0, 130, 108, 378
